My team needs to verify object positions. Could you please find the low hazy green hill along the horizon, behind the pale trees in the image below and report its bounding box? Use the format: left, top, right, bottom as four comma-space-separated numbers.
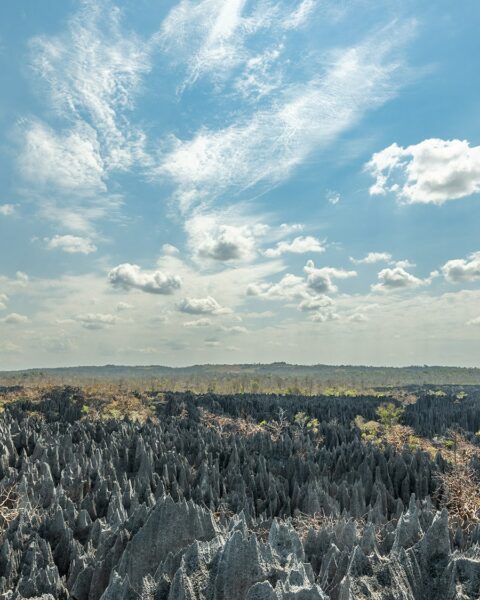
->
0, 362, 480, 389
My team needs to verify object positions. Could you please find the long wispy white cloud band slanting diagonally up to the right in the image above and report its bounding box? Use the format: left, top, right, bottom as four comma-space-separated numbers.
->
153, 26, 405, 211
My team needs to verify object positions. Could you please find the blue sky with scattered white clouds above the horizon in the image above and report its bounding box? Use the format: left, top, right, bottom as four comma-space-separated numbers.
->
0, 0, 480, 370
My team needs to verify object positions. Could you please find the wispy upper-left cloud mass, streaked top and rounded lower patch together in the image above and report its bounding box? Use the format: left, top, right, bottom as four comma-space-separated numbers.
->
17, 0, 154, 231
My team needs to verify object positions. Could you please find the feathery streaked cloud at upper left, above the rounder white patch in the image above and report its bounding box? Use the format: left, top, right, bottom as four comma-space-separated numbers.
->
31, 0, 152, 170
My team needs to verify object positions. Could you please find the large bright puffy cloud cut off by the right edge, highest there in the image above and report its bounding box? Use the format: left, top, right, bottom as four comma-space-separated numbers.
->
366, 138, 480, 204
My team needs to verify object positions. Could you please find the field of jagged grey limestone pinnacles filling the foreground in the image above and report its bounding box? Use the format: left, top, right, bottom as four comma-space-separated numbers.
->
0, 388, 480, 600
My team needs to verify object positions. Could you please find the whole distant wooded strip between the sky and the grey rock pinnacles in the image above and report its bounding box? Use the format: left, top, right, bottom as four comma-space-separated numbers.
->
0, 363, 480, 396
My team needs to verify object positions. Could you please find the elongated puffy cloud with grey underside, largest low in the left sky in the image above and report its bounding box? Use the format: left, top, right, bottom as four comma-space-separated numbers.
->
108, 263, 182, 294
